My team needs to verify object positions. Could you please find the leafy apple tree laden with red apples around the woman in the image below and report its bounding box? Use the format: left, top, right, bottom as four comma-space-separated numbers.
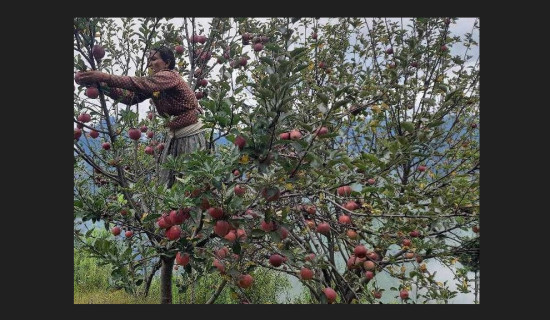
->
73, 18, 480, 303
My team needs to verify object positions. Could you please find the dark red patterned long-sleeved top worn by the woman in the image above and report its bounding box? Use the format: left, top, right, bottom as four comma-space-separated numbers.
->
105, 70, 199, 130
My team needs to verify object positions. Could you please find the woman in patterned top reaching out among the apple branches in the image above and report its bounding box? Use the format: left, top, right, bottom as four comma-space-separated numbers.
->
80, 47, 206, 188
